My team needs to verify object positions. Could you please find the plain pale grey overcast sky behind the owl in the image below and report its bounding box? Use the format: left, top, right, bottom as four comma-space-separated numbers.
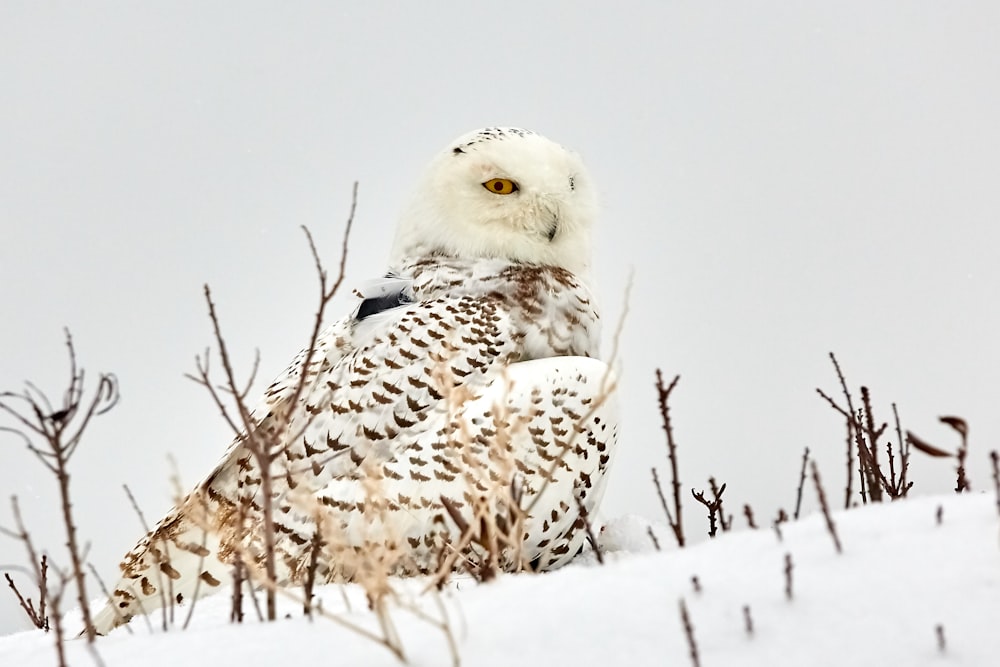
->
0, 0, 1000, 633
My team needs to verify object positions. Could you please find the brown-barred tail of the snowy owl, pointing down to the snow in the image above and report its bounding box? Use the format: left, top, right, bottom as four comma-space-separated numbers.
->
93, 492, 232, 635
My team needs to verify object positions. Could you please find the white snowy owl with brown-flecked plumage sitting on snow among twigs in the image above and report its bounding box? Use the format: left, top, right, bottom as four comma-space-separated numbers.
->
94, 128, 618, 633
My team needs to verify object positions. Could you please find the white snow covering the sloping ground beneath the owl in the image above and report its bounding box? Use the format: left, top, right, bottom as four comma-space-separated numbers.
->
0, 493, 1000, 667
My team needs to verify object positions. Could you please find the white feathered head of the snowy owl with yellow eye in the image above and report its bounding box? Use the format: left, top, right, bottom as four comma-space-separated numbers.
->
392, 127, 597, 275
